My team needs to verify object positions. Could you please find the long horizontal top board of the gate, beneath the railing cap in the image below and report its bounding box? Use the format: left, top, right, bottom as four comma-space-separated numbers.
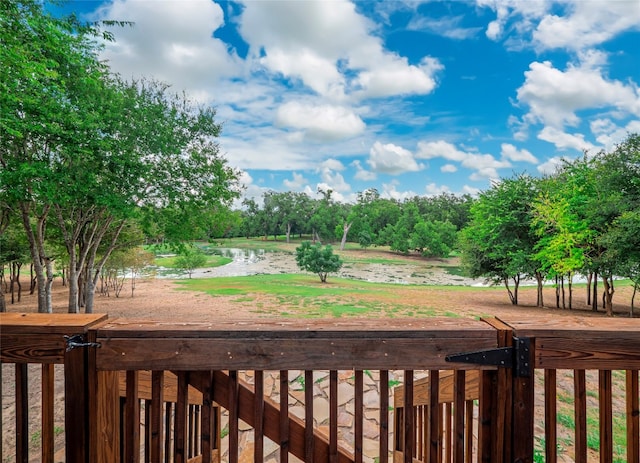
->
97, 333, 495, 370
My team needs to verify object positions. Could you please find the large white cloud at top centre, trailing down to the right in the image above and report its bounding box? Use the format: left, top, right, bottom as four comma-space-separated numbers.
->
240, 0, 442, 101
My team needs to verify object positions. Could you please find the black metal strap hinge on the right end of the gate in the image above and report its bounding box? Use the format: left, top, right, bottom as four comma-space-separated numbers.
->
445, 337, 531, 377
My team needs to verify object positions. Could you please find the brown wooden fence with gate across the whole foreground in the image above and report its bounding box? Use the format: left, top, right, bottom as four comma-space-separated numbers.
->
0, 314, 640, 463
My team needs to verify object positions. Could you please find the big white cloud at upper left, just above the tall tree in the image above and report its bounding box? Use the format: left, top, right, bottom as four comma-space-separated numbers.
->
92, 0, 242, 100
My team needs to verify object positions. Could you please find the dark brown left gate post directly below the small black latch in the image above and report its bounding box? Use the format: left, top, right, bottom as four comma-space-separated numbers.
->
64, 347, 89, 463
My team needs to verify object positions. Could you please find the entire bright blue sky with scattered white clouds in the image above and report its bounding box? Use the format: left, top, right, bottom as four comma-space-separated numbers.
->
57, 0, 640, 201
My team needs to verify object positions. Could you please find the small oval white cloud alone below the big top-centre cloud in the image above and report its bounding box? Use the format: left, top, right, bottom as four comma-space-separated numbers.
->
276, 101, 365, 141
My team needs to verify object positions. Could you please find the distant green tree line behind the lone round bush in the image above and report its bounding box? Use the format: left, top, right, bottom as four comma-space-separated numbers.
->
238, 188, 473, 257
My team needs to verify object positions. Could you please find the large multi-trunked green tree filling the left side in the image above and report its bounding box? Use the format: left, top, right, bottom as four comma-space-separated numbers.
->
0, 0, 239, 312
